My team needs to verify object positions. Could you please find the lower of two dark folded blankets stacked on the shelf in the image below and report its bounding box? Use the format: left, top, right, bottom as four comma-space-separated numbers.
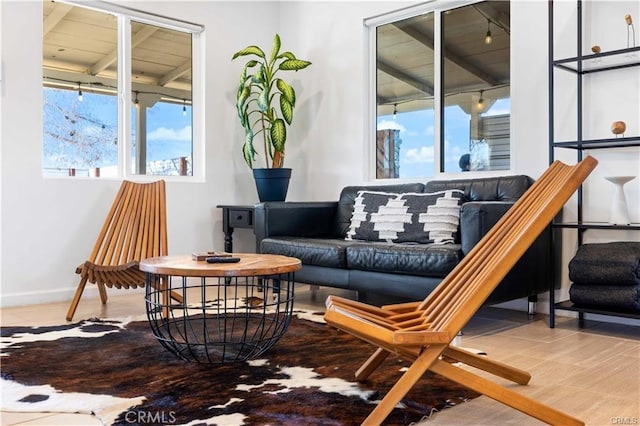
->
569, 283, 640, 312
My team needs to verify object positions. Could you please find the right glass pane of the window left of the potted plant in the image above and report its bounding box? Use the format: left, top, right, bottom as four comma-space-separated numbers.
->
131, 22, 193, 175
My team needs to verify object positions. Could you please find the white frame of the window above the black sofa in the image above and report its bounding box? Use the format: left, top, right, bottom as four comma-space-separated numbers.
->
363, 0, 515, 183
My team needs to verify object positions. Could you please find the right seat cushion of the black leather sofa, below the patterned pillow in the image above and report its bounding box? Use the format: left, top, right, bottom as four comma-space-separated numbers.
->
346, 242, 463, 277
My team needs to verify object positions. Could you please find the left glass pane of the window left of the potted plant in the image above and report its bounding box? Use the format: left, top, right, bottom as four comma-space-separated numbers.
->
42, 2, 118, 176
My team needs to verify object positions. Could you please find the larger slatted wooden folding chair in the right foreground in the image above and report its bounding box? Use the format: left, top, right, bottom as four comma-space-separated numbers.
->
325, 157, 597, 426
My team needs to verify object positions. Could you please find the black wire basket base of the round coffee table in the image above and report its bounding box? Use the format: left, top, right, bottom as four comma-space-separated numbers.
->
145, 273, 294, 364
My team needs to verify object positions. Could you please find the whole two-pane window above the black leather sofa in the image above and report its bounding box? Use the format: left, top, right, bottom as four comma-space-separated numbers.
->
366, 1, 511, 179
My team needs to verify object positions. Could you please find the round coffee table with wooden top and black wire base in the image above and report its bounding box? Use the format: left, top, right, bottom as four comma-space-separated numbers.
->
140, 253, 301, 364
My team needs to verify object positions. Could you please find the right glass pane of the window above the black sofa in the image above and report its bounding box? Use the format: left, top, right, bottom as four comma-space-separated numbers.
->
442, 1, 510, 172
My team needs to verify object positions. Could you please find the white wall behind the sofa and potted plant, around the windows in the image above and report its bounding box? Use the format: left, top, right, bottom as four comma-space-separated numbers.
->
0, 0, 640, 312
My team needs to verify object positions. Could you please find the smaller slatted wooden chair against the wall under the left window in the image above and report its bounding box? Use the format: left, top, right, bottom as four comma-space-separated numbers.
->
67, 180, 182, 321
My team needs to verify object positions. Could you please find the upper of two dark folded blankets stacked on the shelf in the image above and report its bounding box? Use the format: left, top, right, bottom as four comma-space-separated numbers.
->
569, 241, 640, 286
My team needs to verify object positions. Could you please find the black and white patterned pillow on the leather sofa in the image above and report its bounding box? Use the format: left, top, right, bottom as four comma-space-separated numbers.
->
346, 189, 464, 244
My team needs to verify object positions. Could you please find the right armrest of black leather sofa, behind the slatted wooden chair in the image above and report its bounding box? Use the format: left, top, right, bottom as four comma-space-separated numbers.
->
460, 201, 513, 255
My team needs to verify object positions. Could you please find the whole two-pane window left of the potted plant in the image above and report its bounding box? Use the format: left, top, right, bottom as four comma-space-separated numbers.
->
42, 0, 203, 177
